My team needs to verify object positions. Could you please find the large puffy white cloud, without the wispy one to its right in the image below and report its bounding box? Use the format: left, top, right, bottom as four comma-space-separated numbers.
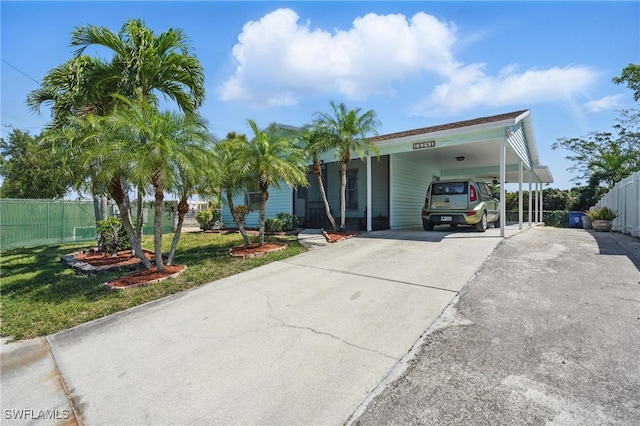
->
220, 9, 459, 106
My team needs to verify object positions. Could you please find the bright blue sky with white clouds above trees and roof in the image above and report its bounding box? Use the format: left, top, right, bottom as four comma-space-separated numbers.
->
0, 0, 640, 189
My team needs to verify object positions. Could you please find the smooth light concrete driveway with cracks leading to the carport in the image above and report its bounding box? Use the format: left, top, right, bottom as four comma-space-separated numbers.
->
2, 227, 517, 425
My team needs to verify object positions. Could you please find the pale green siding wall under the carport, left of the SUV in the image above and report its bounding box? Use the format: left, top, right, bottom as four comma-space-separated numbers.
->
391, 155, 440, 229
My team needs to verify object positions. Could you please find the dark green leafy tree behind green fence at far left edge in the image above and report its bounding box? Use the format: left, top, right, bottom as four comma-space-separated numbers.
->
0, 129, 70, 199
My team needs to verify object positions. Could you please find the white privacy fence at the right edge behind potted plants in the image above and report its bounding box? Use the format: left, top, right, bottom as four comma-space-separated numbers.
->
596, 172, 640, 237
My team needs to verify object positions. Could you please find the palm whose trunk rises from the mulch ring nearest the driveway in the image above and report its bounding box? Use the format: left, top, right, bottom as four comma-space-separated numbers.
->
107, 97, 211, 271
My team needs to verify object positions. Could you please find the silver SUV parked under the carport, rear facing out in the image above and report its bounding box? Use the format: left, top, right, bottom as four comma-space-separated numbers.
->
422, 179, 500, 232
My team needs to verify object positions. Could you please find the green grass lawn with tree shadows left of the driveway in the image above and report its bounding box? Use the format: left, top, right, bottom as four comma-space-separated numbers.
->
0, 233, 305, 340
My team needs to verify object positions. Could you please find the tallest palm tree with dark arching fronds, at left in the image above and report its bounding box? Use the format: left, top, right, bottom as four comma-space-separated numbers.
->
39, 20, 205, 262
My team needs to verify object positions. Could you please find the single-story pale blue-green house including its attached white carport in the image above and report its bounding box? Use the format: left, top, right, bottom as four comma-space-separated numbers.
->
223, 110, 553, 235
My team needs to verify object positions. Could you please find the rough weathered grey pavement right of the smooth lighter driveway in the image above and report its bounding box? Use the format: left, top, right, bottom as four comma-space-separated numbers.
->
349, 227, 640, 426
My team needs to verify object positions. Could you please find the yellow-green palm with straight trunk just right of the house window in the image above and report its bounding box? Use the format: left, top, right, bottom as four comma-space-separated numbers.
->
240, 120, 308, 245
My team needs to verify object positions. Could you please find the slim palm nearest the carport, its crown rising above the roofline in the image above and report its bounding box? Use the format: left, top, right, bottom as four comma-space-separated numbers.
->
315, 101, 380, 231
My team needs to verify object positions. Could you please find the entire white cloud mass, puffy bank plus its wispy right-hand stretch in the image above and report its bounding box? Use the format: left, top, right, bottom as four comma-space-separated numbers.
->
219, 9, 596, 116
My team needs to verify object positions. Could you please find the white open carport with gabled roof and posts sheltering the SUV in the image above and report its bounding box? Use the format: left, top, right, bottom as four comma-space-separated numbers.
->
365, 110, 553, 237
